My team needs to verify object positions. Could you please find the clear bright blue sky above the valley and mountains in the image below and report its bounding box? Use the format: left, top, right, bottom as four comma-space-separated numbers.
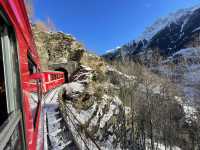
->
33, 0, 200, 55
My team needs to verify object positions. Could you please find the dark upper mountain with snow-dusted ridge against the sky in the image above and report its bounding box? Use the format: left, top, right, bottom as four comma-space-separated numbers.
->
103, 6, 200, 59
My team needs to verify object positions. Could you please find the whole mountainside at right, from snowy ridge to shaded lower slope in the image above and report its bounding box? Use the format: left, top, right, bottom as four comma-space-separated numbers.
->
103, 6, 200, 103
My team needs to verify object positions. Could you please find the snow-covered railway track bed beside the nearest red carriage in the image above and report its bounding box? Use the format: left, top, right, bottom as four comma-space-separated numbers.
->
44, 88, 78, 150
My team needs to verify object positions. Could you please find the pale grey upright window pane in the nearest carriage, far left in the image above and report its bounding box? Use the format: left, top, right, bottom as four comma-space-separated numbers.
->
1, 27, 20, 113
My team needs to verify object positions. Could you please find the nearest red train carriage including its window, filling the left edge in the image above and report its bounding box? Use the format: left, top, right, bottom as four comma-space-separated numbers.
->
0, 0, 44, 150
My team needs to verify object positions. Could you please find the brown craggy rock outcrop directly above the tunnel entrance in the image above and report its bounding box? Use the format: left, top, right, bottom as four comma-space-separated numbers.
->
32, 25, 85, 73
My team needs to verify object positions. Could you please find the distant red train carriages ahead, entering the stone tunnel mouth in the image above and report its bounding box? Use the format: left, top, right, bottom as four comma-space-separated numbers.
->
28, 71, 65, 94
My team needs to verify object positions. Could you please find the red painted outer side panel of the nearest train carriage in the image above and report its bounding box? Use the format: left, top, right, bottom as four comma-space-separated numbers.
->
0, 0, 42, 150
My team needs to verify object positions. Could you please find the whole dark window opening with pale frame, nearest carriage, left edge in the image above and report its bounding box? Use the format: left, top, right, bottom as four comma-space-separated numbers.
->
0, 9, 25, 150
